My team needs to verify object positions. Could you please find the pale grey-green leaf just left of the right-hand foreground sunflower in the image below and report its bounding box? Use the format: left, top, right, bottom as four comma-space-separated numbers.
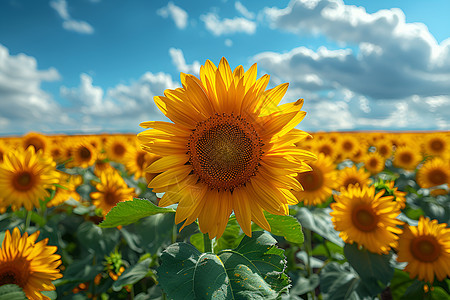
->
296, 207, 344, 247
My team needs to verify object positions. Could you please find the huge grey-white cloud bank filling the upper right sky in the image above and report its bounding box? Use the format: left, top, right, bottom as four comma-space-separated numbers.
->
252, 0, 450, 130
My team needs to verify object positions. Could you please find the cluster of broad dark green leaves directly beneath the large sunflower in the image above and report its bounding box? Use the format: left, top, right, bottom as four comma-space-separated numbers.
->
157, 232, 289, 299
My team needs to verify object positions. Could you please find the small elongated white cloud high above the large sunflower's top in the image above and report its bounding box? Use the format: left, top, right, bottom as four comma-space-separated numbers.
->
200, 13, 256, 36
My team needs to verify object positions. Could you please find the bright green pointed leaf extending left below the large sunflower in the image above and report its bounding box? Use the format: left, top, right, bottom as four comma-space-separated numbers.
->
99, 198, 175, 228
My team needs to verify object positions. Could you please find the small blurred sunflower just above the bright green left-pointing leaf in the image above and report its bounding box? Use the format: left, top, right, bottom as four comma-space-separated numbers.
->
90, 168, 134, 215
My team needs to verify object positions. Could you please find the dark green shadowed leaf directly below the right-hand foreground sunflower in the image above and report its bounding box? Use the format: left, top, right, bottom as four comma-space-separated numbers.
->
344, 244, 394, 296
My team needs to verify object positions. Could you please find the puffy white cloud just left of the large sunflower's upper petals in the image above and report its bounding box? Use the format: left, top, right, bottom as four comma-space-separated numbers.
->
60, 72, 179, 131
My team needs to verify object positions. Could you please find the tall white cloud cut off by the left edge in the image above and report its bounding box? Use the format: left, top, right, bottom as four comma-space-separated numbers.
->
0, 44, 68, 134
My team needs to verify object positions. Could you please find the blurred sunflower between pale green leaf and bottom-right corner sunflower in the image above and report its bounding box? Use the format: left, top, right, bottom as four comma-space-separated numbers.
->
330, 186, 403, 254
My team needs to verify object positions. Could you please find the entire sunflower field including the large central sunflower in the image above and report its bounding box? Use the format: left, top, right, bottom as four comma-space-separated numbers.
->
0, 59, 450, 300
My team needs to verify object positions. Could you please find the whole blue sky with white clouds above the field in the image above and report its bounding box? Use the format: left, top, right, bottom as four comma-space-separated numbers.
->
0, 0, 450, 135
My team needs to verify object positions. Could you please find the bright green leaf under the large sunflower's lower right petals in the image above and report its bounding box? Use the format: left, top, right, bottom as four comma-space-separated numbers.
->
264, 212, 304, 245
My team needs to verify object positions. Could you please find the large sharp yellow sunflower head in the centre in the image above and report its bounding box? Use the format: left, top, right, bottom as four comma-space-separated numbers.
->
138, 58, 315, 238
